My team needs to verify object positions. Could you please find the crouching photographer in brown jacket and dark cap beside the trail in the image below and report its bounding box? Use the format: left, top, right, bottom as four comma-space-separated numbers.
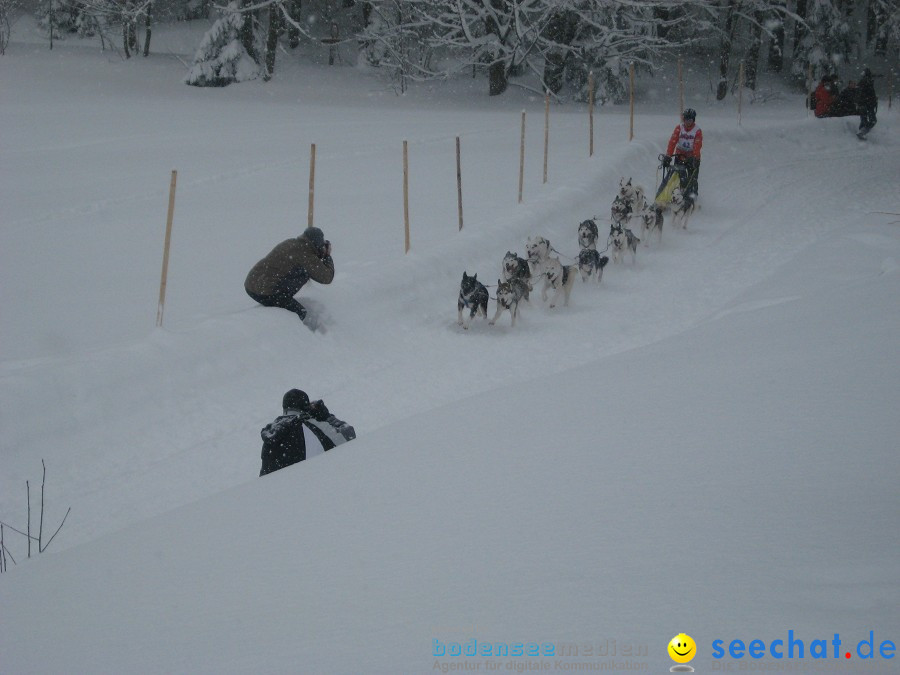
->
244, 227, 334, 321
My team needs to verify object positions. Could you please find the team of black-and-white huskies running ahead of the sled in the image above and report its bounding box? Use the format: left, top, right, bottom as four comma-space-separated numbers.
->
457, 177, 694, 329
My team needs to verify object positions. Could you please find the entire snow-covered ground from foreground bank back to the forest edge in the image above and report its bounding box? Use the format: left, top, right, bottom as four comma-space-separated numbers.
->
0, 18, 900, 673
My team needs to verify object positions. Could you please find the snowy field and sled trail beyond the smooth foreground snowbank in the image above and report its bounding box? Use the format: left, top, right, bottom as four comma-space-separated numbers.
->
0, 45, 898, 548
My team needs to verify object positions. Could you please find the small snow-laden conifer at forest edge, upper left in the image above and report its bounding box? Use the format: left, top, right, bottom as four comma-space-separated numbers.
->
184, 0, 260, 87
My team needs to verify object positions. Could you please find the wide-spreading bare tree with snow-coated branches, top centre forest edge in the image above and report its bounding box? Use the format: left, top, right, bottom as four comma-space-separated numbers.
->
361, 0, 709, 101
